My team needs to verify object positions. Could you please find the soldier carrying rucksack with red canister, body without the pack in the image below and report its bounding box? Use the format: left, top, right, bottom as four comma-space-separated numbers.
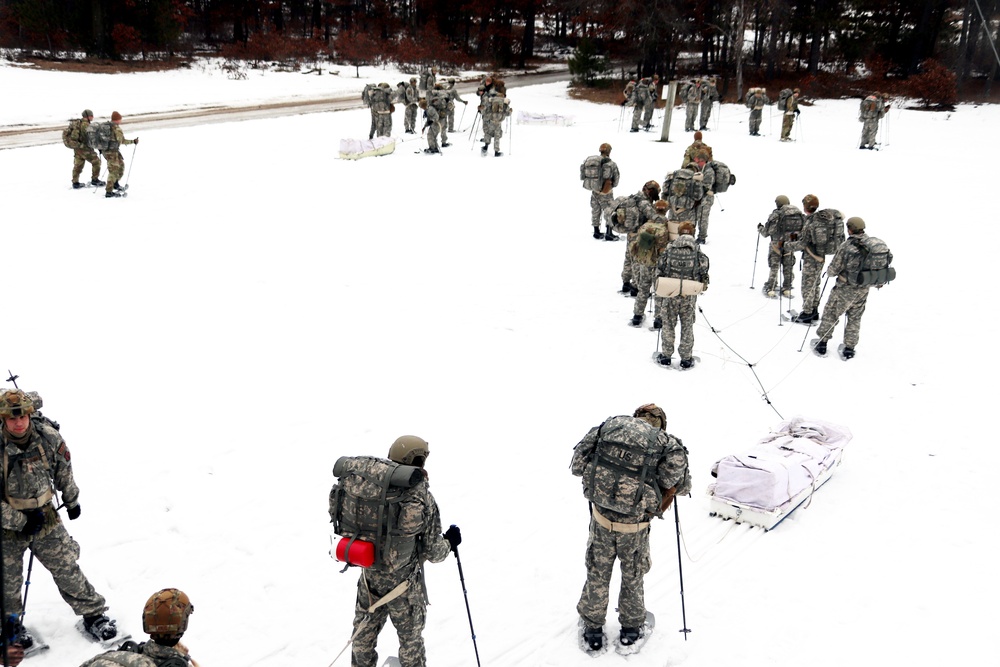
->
331, 435, 462, 667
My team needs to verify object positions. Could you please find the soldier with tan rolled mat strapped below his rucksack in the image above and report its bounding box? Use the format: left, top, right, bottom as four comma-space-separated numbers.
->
656, 221, 709, 368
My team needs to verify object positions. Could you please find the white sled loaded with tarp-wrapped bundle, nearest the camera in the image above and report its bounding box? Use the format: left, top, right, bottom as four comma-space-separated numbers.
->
708, 417, 853, 530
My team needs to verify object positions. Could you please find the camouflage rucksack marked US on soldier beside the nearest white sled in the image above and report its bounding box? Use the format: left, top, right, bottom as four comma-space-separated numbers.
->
573, 416, 665, 516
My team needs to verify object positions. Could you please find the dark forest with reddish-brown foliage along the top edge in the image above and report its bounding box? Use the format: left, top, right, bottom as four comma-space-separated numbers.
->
0, 0, 1000, 108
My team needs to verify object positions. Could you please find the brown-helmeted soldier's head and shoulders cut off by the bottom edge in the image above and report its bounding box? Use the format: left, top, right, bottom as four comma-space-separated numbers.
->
80, 588, 196, 667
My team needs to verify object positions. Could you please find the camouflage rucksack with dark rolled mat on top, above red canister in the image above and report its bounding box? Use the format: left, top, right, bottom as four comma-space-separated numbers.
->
330, 456, 424, 572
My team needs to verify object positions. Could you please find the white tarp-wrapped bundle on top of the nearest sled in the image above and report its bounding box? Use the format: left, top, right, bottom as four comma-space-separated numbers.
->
712, 417, 852, 511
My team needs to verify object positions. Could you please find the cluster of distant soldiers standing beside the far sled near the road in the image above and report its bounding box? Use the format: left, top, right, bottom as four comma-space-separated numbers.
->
361, 67, 511, 157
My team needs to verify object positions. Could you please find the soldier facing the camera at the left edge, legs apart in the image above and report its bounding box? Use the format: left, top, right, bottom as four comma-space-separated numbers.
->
0, 389, 118, 648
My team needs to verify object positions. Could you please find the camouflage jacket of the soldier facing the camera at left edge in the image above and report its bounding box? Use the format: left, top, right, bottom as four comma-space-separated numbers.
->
0, 419, 80, 531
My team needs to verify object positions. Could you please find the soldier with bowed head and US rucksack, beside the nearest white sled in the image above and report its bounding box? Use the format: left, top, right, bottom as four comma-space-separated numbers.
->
570, 403, 691, 651
